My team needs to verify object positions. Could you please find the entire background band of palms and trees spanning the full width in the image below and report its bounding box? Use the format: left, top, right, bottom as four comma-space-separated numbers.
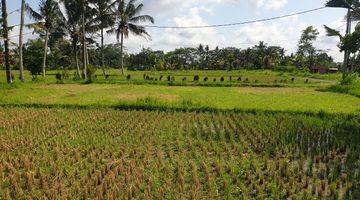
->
1, 0, 360, 83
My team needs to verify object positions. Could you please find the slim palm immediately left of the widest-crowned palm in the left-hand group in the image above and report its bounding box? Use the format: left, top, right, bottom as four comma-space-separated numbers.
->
90, 0, 114, 76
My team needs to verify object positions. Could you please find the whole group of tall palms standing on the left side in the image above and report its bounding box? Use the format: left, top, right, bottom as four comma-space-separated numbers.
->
0, 0, 154, 83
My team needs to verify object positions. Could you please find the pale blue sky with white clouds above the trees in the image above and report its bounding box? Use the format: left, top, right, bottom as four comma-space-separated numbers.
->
8, 0, 354, 61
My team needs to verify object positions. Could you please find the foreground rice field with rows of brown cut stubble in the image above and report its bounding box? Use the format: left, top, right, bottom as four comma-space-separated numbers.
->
0, 107, 360, 199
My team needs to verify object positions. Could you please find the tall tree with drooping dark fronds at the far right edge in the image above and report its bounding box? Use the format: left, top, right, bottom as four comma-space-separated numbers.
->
325, 0, 360, 77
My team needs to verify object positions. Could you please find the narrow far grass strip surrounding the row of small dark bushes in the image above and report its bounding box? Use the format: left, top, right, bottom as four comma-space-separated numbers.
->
0, 69, 340, 87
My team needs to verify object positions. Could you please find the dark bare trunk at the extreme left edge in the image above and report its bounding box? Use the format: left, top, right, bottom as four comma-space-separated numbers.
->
1, 0, 13, 84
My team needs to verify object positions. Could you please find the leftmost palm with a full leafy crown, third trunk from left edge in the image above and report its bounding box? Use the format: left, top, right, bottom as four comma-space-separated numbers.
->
27, 0, 61, 77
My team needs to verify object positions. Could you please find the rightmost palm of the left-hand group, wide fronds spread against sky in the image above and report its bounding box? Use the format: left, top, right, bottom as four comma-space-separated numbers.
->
108, 0, 155, 75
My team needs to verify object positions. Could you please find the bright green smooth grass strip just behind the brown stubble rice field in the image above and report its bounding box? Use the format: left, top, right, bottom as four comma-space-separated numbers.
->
0, 83, 360, 113
